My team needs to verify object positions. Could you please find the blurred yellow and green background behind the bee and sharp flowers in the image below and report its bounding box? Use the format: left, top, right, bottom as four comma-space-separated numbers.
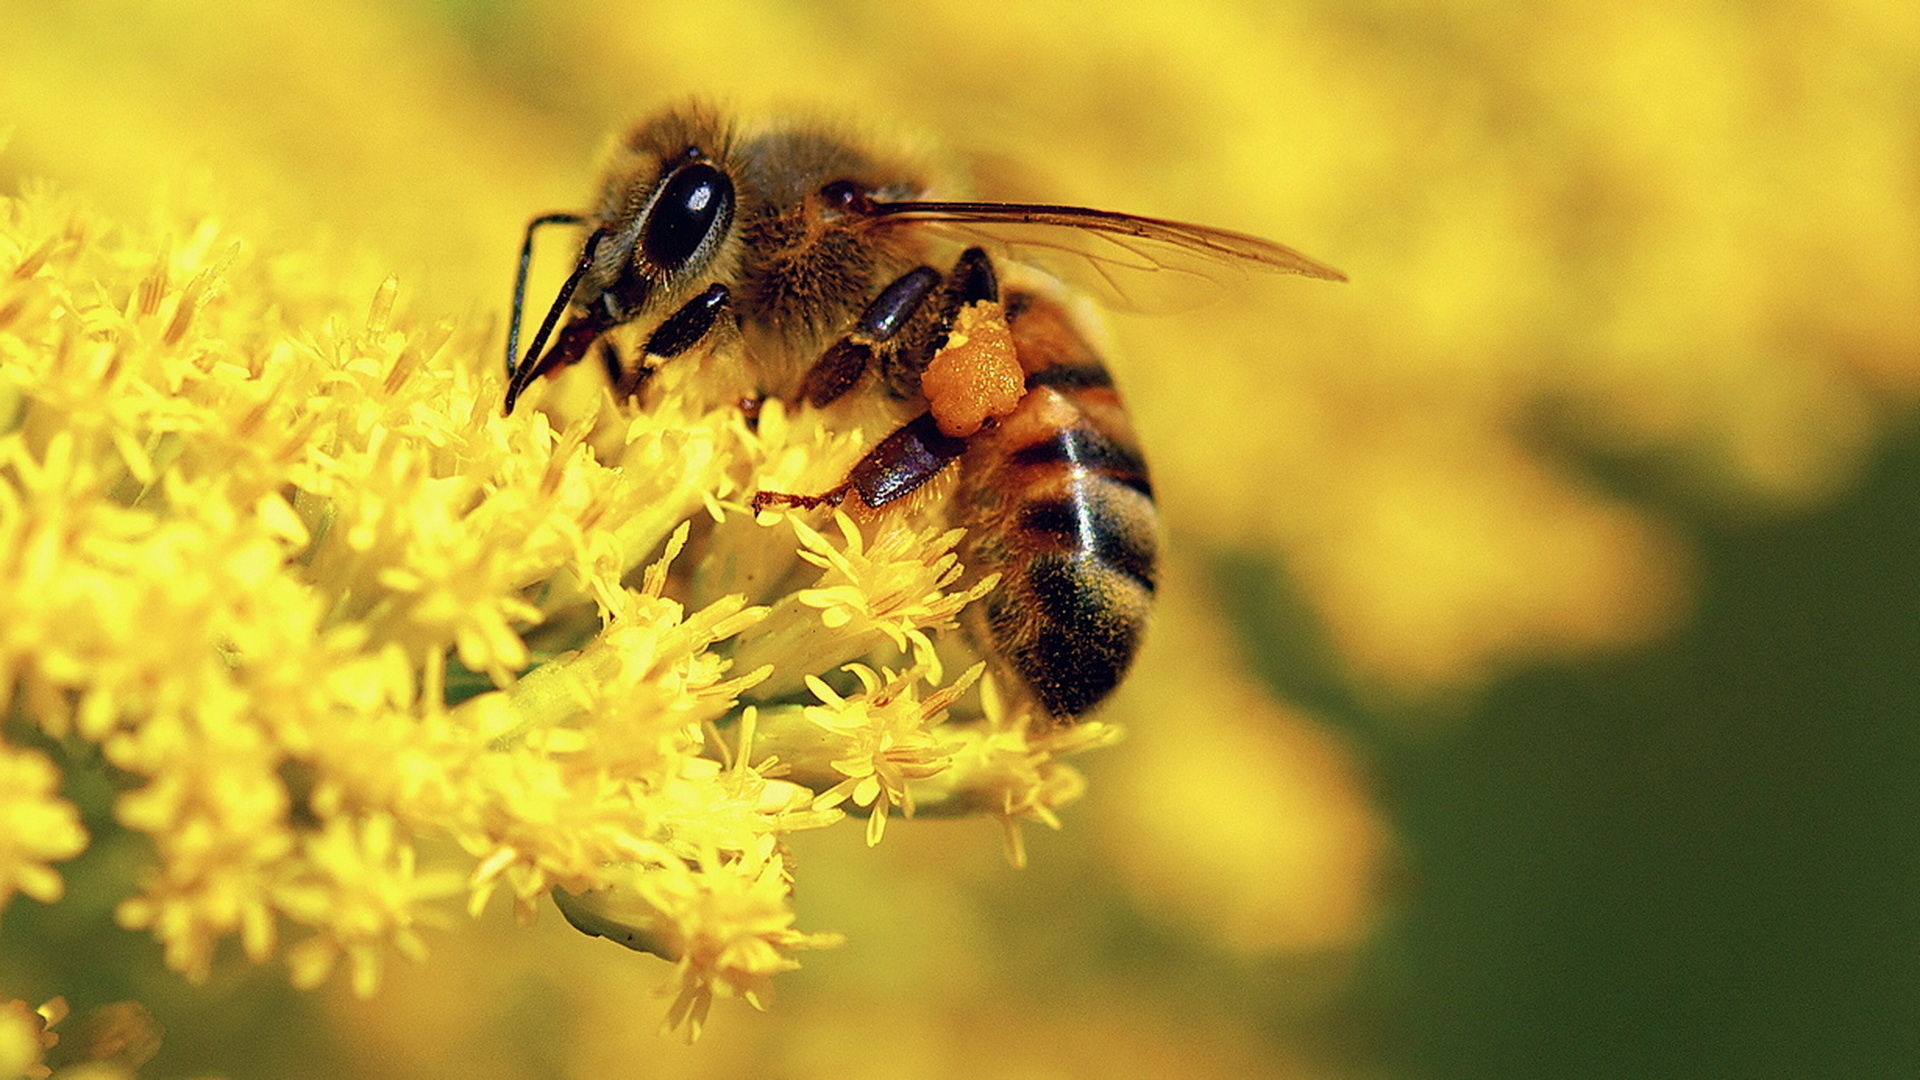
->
0, 0, 1920, 1078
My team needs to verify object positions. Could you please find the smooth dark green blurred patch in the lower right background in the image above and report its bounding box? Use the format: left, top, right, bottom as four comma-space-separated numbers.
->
1227, 424, 1920, 1078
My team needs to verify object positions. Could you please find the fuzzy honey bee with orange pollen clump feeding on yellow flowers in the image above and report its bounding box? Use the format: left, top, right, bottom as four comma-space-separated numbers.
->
505, 106, 1344, 724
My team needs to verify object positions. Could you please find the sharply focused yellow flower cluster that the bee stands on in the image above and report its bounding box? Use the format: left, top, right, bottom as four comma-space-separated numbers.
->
0, 182, 1114, 1034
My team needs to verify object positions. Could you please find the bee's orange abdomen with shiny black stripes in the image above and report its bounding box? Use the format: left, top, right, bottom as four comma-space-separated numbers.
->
962, 294, 1158, 723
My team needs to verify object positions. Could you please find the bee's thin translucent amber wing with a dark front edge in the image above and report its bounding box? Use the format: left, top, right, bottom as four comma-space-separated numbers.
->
868, 202, 1346, 311
